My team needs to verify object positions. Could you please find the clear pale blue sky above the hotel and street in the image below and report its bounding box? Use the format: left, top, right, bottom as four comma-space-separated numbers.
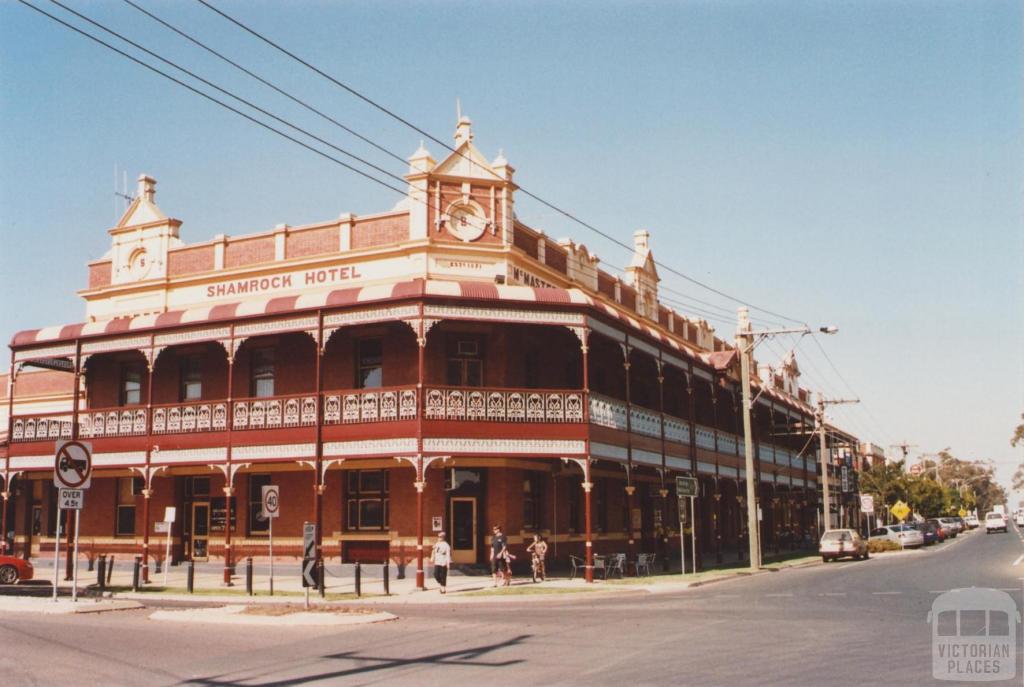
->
0, 0, 1024, 495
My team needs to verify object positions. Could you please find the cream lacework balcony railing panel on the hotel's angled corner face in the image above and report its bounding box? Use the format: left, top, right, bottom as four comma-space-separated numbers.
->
424, 387, 584, 423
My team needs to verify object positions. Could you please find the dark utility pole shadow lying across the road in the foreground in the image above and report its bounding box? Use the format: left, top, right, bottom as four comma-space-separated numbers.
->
179, 635, 532, 687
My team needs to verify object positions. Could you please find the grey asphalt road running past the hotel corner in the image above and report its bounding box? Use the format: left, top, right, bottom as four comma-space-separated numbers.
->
0, 530, 1024, 687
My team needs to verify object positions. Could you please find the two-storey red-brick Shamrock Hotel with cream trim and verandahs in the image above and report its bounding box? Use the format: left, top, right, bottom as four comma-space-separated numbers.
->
0, 118, 856, 575
